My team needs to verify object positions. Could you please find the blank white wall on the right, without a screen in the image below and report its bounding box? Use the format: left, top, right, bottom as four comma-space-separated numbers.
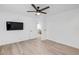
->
45, 9, 79, 48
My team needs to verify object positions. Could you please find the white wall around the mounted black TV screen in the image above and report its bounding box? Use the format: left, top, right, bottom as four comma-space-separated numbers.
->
0, 12, 37, 45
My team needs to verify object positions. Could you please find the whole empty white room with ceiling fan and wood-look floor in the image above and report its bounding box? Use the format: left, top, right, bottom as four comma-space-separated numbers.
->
0, 4, 79, 55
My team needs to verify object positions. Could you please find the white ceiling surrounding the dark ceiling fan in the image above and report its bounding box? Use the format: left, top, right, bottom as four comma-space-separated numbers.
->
0, 4, 79, 15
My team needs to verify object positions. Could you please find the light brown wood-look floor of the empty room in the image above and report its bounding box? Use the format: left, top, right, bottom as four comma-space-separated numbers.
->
0, 39, 79, 55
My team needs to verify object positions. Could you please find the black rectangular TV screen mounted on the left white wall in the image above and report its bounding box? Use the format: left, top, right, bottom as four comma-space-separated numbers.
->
6, 21, 23, 30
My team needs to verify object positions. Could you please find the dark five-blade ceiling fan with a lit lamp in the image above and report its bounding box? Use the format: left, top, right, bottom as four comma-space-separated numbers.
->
27, 4, 50, 15
